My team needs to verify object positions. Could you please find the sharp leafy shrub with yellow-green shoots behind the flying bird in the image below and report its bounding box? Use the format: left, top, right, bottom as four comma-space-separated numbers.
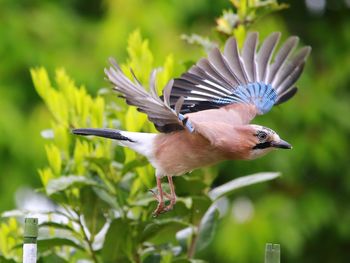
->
0, 1, 288, 263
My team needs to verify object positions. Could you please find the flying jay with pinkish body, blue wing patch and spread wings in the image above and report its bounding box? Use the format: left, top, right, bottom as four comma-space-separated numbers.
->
72, 32, 311, 216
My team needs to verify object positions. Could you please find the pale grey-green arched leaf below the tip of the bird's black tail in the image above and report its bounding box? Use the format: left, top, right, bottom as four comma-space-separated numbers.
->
46, 175, 99, 195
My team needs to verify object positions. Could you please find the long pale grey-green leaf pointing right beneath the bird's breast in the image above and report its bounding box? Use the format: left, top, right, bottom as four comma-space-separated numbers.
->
209, 172, 281, 200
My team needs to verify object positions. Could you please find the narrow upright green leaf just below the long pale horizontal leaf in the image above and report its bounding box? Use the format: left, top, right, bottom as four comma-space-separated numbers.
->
195, 205, 219, 253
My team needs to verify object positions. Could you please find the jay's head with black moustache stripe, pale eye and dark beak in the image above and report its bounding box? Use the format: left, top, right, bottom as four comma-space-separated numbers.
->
243, 125, 292, 159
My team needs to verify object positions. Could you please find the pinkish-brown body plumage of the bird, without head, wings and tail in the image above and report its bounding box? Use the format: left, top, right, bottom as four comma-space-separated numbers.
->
154, 122, 256, 176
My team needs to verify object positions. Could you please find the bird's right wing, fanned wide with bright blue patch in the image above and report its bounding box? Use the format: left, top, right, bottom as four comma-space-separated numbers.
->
170, 32, 311, 123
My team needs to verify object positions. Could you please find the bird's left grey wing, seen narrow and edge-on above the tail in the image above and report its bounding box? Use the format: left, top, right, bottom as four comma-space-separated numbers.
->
105, 59, 186, 132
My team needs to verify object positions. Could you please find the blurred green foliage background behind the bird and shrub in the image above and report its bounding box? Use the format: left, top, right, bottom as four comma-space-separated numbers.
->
0, 0, 350, 262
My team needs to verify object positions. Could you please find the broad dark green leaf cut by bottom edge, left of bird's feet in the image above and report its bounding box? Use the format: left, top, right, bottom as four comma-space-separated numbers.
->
101, 218, 135, 263
